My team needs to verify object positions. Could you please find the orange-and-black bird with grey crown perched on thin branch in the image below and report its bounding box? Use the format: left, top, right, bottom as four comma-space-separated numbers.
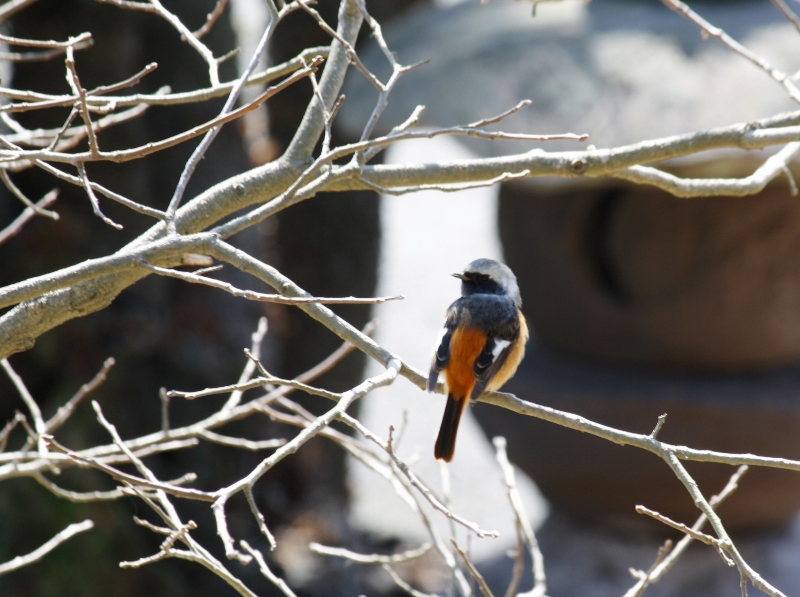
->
427, 258, 529, 462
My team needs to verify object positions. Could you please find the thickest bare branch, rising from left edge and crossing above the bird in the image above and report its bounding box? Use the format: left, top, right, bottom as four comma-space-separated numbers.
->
0, 111, 800, 364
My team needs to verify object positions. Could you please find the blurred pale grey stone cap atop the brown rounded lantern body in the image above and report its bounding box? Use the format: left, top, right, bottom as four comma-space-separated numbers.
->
339, 0, 800, 156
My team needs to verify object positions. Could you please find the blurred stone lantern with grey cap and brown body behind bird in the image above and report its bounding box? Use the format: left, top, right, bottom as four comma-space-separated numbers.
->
344, 0, 800, 529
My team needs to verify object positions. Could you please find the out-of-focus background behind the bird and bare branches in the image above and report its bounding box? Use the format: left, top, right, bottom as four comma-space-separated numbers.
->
0, 0, 800, 596
